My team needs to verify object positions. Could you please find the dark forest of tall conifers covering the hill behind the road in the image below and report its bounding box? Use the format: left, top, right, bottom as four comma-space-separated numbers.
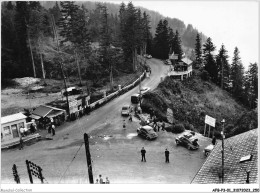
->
1, 1, 258, 109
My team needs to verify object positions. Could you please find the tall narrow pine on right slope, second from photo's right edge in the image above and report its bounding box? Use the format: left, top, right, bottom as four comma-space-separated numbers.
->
230, 47, 244, 101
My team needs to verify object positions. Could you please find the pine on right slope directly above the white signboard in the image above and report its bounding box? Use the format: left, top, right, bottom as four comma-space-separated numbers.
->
203, 37, 218, 83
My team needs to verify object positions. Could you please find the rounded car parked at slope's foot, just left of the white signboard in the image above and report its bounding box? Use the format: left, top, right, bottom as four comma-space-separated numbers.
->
175, 132, 199, 150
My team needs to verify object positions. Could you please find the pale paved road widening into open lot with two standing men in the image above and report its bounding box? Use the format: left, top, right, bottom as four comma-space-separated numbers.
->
1, 59, 209, 183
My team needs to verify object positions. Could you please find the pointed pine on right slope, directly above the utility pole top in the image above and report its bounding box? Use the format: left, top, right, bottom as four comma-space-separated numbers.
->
216, 44, 230, 90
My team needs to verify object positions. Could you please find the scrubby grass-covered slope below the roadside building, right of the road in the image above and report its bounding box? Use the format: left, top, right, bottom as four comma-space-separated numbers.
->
142, 71, 257, 137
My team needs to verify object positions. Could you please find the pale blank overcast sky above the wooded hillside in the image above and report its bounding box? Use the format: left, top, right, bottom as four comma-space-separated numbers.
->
107, 0, 259, 67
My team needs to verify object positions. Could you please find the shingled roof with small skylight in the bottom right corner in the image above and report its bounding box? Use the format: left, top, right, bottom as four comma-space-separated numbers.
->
191, 129, 258, 184
